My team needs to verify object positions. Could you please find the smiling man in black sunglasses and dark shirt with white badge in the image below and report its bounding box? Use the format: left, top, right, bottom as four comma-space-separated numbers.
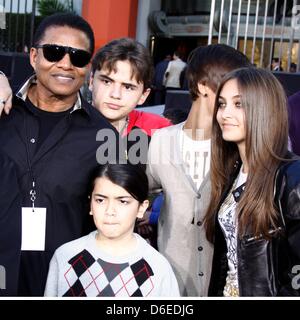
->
0, 14, 118, 296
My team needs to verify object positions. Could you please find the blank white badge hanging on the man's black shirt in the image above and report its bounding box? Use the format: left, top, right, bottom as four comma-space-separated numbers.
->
21, 207, 46, 251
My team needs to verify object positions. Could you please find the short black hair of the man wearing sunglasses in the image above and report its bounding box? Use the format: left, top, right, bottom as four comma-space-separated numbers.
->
33, 13, 95, 54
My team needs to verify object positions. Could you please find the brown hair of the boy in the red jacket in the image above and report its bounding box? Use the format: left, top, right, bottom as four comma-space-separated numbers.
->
92, 38, 154, 90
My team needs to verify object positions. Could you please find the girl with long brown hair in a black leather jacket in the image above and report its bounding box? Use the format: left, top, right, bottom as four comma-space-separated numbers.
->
205, 68, 300, 296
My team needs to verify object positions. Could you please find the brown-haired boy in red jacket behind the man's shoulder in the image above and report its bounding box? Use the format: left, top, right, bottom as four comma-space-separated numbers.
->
89, 38, 171, 164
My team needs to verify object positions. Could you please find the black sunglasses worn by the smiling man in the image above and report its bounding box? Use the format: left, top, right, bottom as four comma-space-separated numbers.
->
35, 44, 91, 68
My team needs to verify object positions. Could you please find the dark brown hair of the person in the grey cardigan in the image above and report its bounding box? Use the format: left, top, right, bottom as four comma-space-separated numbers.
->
187, 44, 252, 101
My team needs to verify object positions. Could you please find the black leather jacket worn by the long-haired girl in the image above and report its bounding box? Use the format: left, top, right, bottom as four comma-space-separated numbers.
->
208, 155, 300, 296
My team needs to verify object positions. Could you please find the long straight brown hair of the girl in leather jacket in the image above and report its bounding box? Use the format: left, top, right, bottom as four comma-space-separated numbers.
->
205, 68, 288, 241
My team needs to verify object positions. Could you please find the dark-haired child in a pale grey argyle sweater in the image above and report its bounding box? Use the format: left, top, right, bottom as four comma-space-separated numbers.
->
45, 164, 179, 297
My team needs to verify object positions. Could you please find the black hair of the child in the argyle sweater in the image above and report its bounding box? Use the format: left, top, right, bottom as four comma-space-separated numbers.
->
89, 163, 149, 203
